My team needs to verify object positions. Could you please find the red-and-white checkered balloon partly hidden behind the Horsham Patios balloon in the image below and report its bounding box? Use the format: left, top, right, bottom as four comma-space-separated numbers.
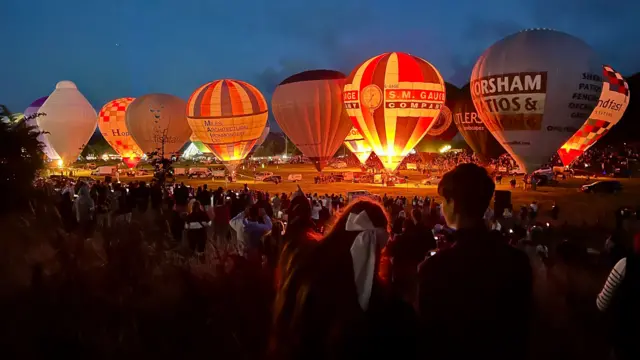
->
558, 65, 630, 165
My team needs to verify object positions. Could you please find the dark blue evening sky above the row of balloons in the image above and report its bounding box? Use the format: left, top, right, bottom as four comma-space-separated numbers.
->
0, 0, 640, 129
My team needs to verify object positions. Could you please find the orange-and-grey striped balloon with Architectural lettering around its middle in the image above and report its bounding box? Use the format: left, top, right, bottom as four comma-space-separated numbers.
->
187, 79, 268, 173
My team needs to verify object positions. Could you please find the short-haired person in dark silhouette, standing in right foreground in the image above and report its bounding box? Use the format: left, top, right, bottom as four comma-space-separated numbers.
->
418, 164, 532, 360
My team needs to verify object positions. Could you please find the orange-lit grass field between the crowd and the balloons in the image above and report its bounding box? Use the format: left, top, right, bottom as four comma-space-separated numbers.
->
66, 164, 640, 226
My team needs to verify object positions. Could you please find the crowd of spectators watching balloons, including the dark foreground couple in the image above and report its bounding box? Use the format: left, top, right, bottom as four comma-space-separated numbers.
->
22, 160, 640, 359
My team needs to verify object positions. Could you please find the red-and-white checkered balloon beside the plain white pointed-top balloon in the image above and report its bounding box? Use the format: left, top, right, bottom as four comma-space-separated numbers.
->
98, 97, 144, 168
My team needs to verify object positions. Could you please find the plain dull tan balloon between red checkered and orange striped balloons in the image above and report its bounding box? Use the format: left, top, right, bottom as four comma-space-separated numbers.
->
126, 94, 191, 154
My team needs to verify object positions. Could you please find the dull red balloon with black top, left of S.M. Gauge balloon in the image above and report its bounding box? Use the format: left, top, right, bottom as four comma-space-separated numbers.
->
271, 70, 353, 171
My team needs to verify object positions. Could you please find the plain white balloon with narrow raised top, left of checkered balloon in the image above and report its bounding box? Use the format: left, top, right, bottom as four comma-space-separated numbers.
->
36, 80, 97, 164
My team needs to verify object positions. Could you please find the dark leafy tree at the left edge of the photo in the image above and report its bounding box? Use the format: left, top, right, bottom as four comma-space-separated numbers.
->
0, 105, 44, 212
